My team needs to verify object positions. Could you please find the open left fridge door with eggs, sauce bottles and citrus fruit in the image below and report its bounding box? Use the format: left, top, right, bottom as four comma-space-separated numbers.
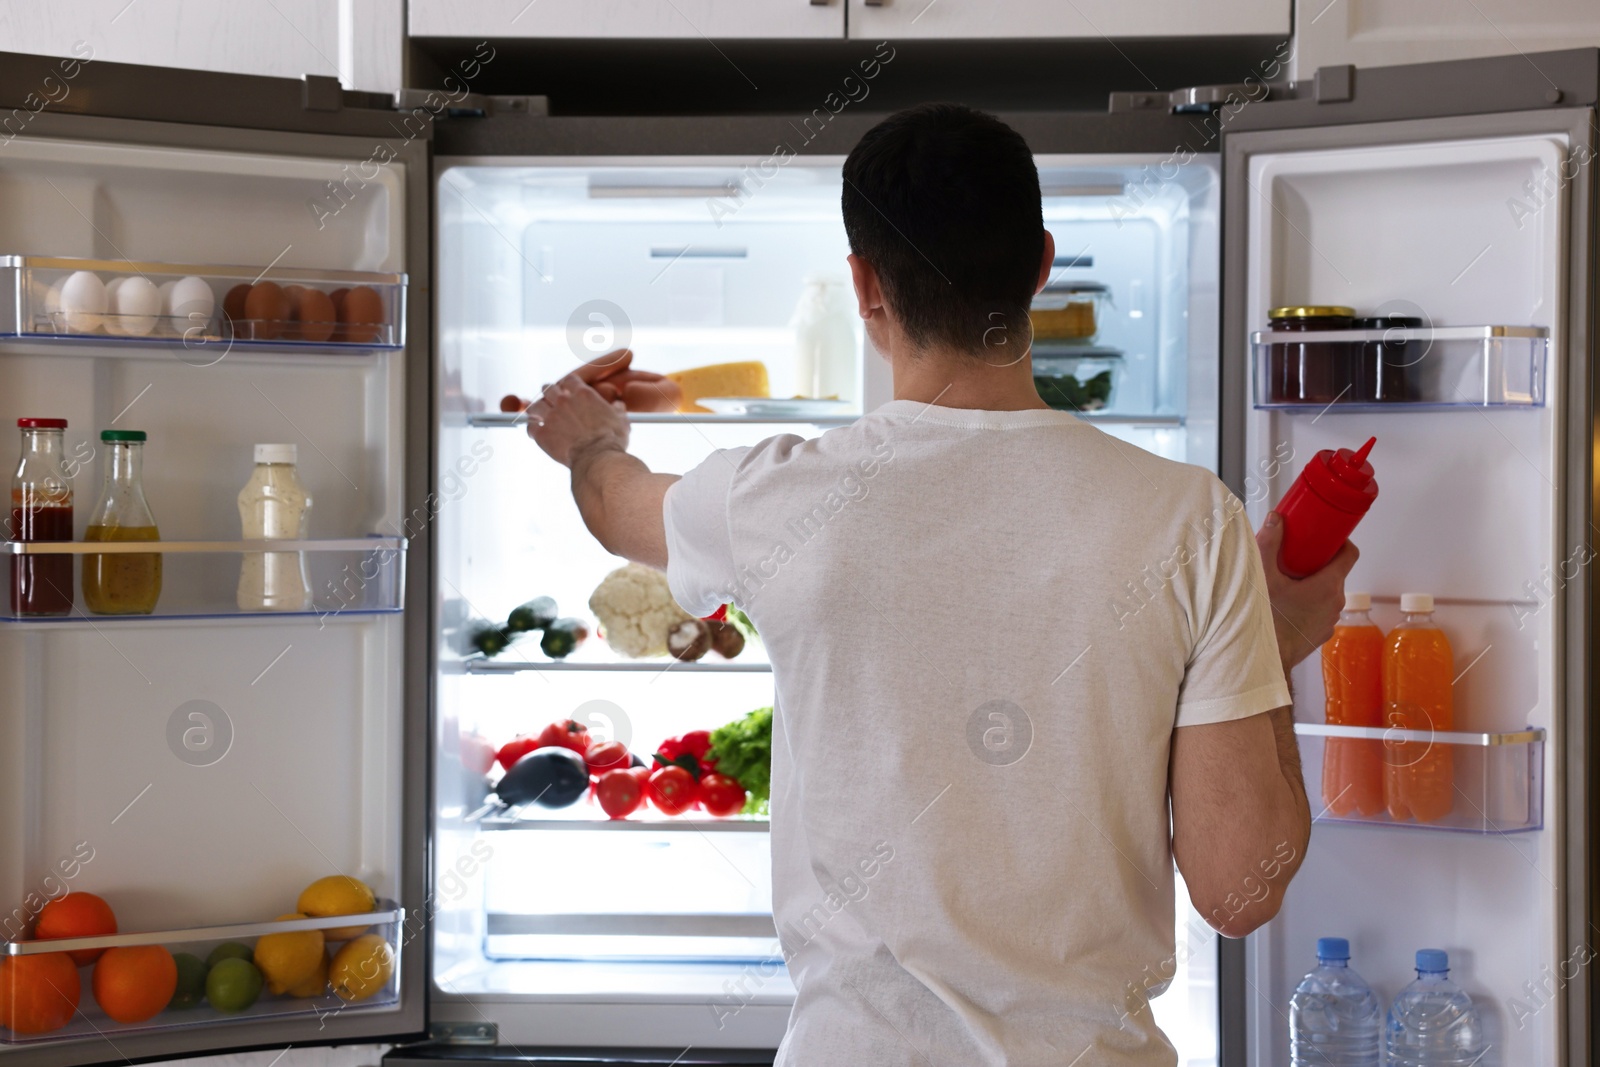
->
0, 56, 429, 1064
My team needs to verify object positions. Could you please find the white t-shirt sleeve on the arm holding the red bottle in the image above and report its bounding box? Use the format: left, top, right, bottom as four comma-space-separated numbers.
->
1176, 496, 1290, 726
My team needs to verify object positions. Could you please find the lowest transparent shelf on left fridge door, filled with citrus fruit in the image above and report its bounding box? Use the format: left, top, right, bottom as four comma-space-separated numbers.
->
0, 901, 406, 1045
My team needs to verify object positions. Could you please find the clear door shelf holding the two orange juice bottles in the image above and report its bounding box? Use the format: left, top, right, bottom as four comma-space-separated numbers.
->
1294, 723, 1544, 835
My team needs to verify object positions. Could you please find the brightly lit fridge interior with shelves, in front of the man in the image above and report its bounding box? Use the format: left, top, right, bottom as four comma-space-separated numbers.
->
425, 103, 1221, 1067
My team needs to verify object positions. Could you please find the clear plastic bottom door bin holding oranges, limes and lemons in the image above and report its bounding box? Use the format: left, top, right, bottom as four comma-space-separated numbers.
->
0, 901, 405, 1045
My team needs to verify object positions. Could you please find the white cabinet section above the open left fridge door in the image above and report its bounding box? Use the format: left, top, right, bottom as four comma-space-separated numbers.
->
0, 0, 405, 93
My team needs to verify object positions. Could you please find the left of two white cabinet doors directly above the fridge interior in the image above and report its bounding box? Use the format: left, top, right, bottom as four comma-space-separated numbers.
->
410, 0, 846, 38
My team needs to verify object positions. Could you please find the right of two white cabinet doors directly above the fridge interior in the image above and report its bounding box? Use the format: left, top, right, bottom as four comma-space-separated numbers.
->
851, 0, 1290, 40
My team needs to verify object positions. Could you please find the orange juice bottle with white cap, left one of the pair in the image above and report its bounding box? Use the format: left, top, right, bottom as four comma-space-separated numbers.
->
1322, 593, 1384, 817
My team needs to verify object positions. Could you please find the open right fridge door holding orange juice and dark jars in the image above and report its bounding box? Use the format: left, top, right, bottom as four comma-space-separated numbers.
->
1222, 53, 1595, 1067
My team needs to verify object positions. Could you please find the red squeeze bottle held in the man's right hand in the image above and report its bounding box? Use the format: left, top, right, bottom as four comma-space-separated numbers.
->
1274, 437, 1378, 577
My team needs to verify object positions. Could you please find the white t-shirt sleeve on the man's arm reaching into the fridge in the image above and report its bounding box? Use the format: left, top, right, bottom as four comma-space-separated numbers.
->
662, 448, 750, 616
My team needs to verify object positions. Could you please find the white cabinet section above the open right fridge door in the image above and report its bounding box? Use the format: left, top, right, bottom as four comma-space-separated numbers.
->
1286, 0, 1600, 78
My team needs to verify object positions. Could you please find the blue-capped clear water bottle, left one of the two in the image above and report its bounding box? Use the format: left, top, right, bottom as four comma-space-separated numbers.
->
1290, 937, 1384, 1067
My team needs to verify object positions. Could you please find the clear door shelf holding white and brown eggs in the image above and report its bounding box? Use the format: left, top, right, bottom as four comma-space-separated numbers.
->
0, 256, 406, 350
